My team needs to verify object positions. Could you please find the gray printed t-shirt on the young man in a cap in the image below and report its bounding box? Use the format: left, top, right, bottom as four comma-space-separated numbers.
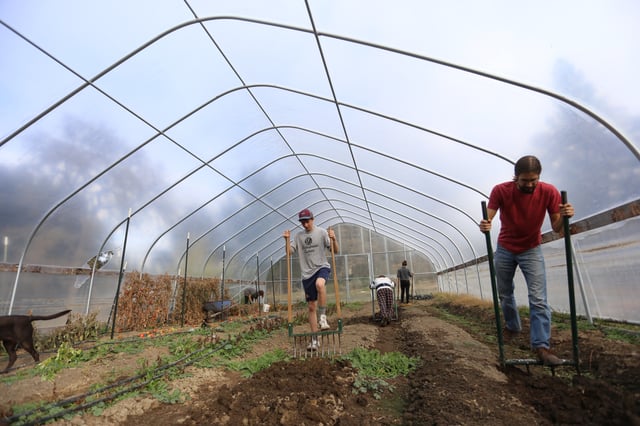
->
291, 226, 331, 280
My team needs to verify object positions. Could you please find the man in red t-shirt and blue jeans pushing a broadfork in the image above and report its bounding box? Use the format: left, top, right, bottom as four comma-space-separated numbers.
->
480, 155, 574, 365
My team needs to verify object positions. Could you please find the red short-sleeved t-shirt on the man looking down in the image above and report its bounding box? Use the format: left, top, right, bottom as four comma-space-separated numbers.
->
487, 181, 562, 254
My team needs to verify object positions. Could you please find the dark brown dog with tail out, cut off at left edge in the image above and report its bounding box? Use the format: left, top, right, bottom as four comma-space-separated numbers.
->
0, 309, 71, 374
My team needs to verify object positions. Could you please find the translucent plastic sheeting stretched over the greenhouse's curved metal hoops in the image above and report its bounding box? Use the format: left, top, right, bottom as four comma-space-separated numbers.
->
0, 0, 640, 321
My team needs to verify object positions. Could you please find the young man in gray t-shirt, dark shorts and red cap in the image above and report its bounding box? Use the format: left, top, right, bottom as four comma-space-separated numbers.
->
283, 209, 338, 350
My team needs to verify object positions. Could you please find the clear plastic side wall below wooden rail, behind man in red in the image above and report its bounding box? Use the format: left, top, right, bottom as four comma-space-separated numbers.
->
462, 217, 640, 324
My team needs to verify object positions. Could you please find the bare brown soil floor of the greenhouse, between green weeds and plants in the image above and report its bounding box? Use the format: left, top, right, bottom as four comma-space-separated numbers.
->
0, 300, 640, 426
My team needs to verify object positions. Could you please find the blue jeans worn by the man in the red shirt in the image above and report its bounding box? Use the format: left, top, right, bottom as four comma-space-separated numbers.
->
493, 244, 551, 349
